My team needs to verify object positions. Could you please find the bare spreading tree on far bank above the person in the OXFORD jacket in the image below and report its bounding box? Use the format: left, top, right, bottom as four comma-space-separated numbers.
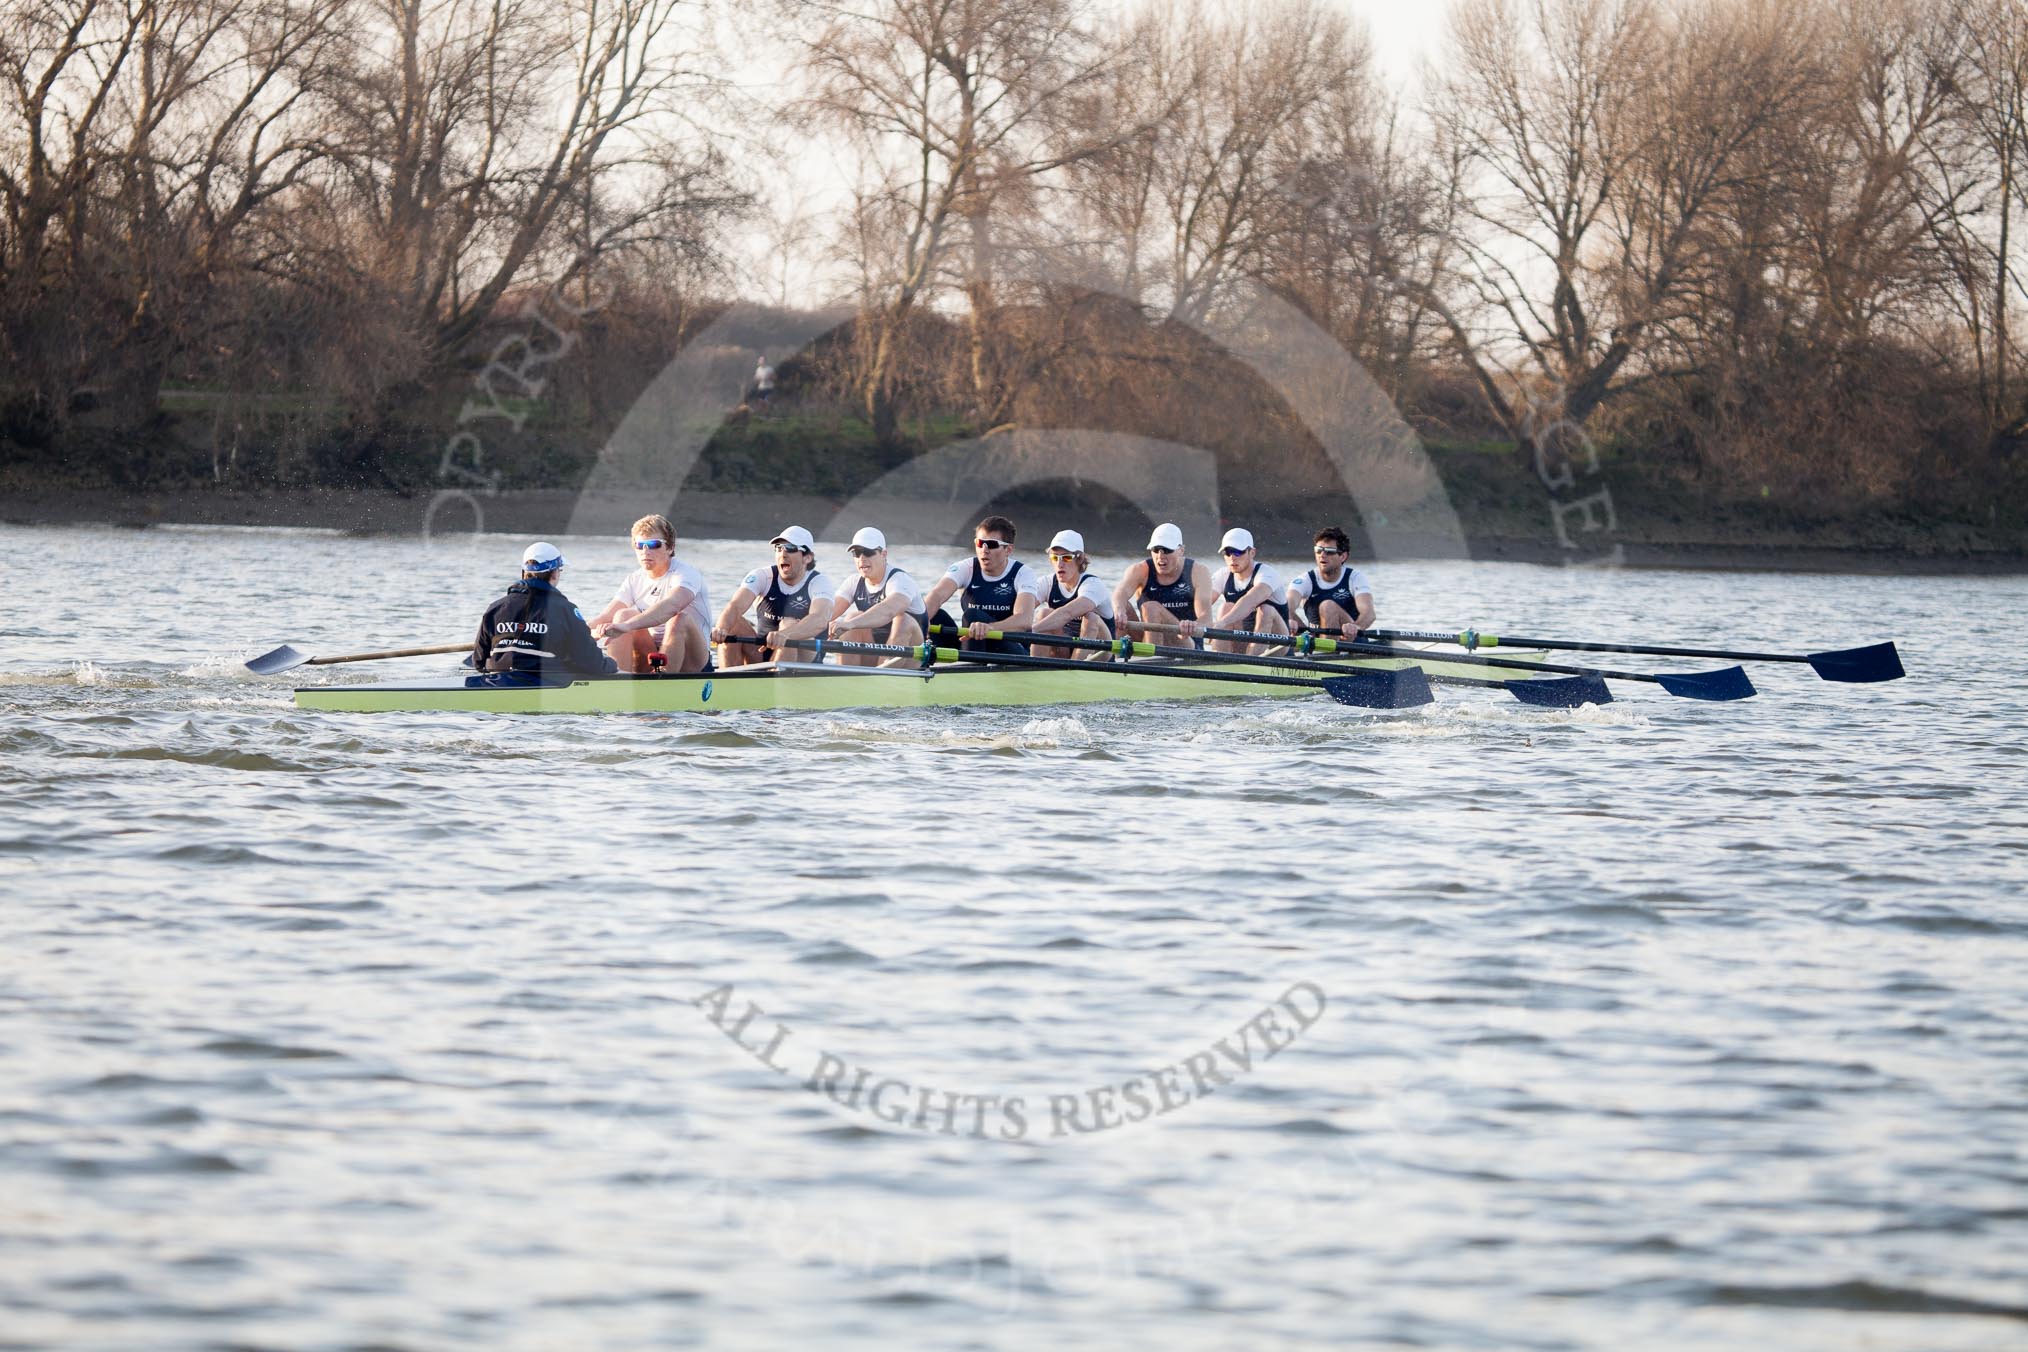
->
316, 0, 732, 374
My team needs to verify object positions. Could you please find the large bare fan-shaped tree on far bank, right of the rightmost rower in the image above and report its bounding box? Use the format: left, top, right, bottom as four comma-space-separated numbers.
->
1434, 0, 1817, 462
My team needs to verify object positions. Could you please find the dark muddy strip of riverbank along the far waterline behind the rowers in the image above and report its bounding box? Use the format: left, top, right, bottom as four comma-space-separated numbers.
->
0, 489, 2028, 574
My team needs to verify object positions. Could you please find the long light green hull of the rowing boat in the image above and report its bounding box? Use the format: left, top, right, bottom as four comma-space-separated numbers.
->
296, 655, 1533, 713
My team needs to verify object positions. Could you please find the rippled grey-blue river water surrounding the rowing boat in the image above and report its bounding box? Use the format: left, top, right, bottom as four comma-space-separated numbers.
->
0, 527, 2028, 1350
